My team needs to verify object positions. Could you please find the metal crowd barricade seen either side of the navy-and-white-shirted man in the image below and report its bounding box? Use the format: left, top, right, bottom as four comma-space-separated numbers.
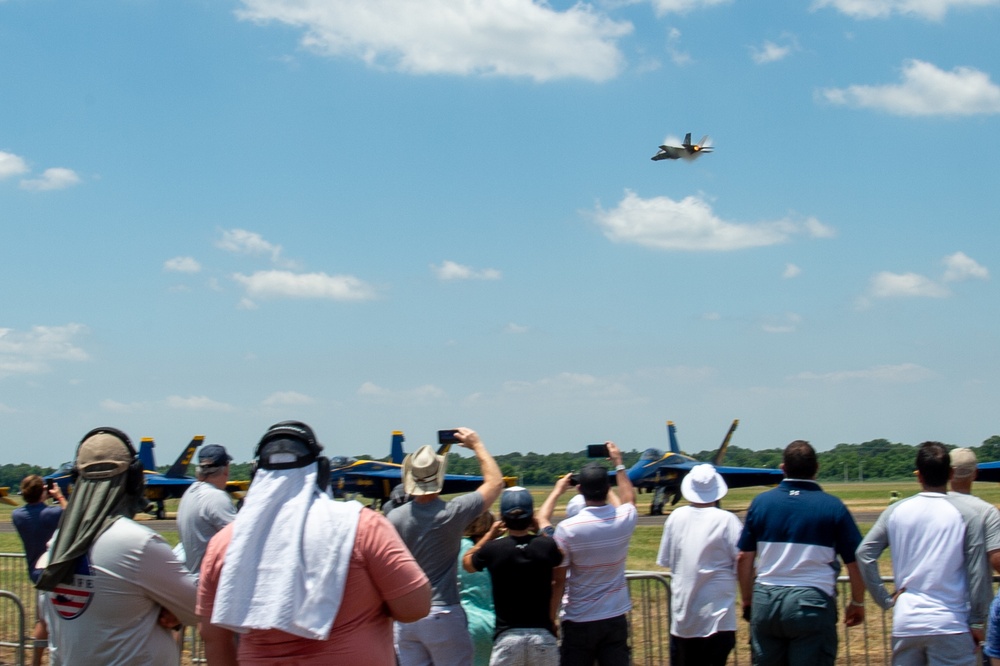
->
625, 571, 916, 666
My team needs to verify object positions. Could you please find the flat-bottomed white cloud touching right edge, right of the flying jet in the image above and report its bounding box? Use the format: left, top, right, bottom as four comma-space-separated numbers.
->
818, 60, 1000, 116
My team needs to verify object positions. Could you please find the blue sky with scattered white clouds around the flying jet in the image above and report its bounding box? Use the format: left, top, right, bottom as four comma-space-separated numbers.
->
0, 0, 1000, 465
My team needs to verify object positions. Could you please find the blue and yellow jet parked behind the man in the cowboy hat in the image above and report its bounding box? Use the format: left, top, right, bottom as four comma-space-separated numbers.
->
330, 430, 517, 509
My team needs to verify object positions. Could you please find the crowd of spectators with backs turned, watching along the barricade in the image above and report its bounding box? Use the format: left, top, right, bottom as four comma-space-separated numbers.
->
13, 421, 1000, 666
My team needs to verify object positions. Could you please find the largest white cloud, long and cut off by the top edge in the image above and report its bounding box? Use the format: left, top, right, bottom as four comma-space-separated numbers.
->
237, 0, 633, 81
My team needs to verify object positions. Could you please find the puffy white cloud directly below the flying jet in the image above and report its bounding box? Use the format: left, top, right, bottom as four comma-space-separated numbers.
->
594, 190, 833, 252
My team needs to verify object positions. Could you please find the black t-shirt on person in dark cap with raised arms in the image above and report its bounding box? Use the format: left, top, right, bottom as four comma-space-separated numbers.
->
472, 534, 562, 638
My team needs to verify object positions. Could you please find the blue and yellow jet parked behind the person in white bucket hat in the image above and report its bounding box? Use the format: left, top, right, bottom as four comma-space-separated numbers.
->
628, 419, 784, 516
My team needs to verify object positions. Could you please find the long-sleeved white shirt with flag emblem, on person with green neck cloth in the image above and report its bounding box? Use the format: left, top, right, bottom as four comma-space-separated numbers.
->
45, 518, 198, 666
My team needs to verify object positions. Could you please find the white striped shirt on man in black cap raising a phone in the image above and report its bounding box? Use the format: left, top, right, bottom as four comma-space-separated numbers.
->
555, 503, 638, 622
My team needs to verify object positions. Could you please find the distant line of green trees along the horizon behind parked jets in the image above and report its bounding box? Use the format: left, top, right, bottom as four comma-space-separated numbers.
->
0, 435, 1000, 494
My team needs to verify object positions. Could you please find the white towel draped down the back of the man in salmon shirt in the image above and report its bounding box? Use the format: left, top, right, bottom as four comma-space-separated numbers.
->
212, 463, 362, 640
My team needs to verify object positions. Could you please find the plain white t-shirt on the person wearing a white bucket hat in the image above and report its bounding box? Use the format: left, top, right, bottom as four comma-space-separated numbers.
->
656, 506, 743, 638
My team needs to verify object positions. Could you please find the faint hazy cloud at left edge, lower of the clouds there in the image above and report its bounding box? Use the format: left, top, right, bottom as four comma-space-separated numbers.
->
0, 324, 89, 379
